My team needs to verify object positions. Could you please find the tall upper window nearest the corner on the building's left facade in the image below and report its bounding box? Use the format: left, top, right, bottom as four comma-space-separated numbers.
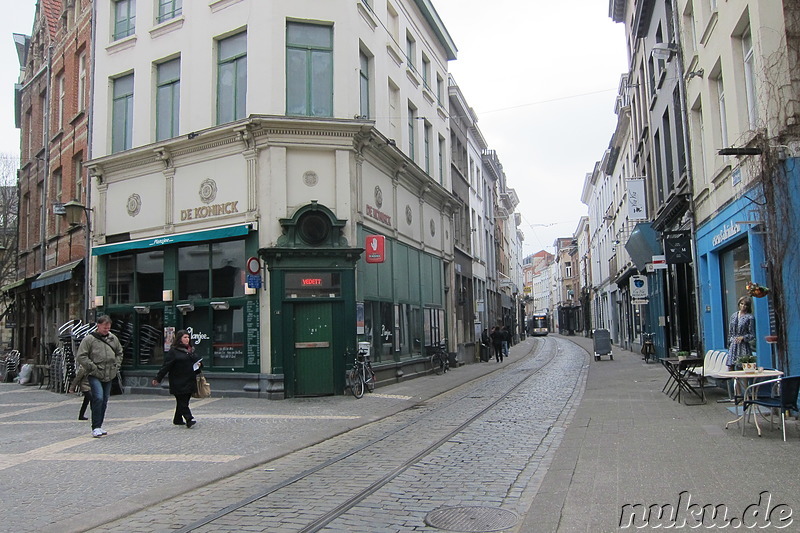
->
217, 32, 247, 124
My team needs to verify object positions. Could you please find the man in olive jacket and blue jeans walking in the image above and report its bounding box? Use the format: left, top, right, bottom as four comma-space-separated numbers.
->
75, 315, 122, 438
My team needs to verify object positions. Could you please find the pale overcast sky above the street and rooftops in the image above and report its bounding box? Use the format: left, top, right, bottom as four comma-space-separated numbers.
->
0, 0, 627, 255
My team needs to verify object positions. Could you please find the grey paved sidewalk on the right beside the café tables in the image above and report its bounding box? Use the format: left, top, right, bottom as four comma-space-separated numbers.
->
519, 335, 800, 533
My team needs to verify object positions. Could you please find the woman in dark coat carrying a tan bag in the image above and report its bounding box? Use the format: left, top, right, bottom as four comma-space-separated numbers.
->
153, 329, 203, 428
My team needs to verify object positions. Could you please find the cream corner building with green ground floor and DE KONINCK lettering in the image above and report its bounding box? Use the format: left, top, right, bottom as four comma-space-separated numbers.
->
87, 0, 458, 399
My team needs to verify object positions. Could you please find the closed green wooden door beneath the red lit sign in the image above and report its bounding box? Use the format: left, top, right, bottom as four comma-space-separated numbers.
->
294, 302, 334, 396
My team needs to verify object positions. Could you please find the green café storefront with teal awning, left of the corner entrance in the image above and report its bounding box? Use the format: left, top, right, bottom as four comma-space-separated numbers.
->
92, 224, 261, 392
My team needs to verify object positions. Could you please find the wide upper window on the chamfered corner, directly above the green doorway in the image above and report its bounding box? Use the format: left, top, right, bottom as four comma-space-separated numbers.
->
286, 22, 333, 117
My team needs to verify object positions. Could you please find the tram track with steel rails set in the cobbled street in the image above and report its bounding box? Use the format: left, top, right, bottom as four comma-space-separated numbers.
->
95, 338, 588, 532
